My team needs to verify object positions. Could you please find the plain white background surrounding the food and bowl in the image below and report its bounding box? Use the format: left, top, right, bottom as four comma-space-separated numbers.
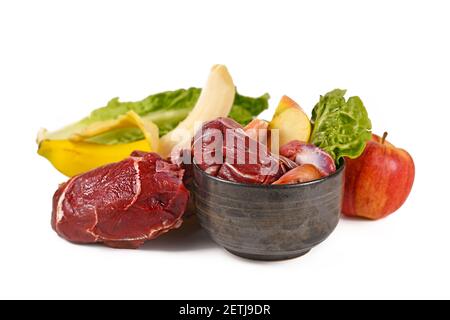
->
0, 0, 450, 299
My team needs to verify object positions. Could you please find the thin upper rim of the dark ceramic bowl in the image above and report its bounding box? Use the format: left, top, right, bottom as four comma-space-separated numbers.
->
192, 158, 346, 190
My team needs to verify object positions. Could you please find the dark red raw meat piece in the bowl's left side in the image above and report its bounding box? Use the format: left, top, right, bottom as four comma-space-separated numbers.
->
193, 118, 285, 184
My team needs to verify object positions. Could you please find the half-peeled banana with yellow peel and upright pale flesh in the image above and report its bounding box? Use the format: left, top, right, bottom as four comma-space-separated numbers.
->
37, 65, 236, 177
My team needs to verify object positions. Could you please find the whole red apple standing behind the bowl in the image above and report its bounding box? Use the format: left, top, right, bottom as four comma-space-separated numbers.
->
342, 133, 415, 220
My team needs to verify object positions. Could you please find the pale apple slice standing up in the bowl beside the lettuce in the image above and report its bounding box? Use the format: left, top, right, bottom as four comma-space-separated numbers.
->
269, 96, 311, 146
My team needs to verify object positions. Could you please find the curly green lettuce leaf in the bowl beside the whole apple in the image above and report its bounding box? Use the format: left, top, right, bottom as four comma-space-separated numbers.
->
311, 89, 372, 162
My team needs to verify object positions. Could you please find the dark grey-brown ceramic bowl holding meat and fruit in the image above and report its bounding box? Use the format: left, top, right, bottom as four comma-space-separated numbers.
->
194, 162, 345, 260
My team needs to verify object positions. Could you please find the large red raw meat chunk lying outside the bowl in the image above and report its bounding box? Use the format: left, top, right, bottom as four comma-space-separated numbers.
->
52, 152, 189, 248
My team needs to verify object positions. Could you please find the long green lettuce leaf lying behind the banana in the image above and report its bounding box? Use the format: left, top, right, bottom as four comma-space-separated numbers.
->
47, 88, 269, 144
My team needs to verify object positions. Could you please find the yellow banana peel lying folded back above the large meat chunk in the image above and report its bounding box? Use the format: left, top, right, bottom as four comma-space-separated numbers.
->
37, 111, 159, 177
